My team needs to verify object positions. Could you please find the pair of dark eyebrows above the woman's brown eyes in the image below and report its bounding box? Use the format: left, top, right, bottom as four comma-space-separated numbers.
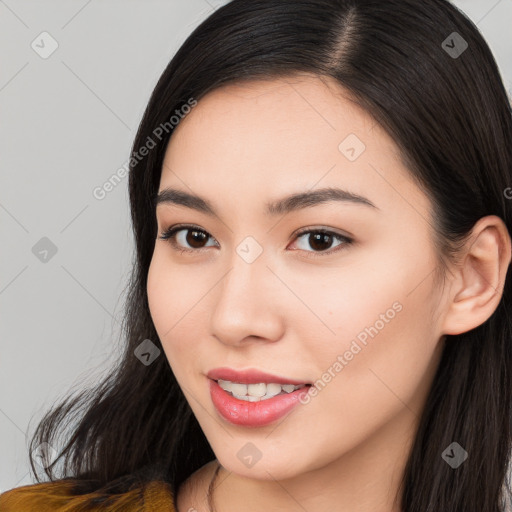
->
156, 187, 379, 217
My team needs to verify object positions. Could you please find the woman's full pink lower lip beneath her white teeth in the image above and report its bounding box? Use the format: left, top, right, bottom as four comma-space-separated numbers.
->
209, 379, 309, 427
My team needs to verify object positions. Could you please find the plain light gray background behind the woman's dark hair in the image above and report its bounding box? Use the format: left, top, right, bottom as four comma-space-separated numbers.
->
0, 0, 512, 492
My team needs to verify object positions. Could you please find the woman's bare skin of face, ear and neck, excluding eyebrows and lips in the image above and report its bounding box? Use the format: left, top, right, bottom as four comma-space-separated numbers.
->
147, 75, 511, 512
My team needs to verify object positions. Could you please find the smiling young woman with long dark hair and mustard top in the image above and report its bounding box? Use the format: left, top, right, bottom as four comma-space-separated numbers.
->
0, 0, 512, 512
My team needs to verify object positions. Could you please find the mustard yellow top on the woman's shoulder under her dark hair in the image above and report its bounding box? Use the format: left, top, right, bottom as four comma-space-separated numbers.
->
0, 480, 176, 512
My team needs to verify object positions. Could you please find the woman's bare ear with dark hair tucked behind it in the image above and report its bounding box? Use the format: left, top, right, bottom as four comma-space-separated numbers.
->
442, 215, 512, 334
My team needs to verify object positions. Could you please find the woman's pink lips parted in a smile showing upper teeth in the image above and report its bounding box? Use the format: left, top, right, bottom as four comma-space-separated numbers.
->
208, 368, 311, 427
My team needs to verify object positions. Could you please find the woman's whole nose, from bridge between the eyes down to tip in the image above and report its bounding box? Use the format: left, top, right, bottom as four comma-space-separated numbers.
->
212, 237, 286, 344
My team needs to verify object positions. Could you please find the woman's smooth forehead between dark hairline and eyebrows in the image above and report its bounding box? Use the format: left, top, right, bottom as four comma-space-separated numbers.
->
160, 75, 428, 225
